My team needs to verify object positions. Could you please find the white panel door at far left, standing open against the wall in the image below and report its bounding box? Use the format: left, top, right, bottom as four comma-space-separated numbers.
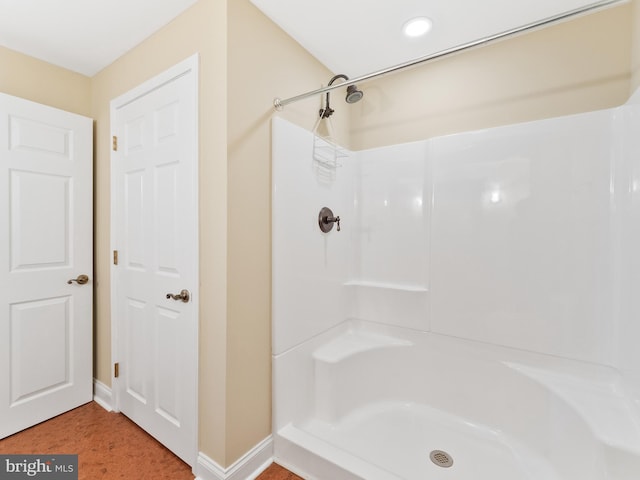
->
0, 94, 93, 438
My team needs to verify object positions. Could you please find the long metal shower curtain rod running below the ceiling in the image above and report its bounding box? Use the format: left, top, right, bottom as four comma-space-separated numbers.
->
273, 0, 629, 110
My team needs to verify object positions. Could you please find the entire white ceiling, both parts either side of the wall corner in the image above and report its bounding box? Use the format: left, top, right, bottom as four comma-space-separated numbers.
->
0, 0, 624, 77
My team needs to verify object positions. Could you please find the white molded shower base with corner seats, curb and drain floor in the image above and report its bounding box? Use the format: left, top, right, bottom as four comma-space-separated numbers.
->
274, 321, 640, 480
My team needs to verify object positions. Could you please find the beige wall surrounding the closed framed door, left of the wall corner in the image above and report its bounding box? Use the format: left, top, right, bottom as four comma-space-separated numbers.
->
92, 0, 227, 465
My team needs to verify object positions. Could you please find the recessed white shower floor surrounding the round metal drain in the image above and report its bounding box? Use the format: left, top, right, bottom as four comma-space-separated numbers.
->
278, 404, 560, 480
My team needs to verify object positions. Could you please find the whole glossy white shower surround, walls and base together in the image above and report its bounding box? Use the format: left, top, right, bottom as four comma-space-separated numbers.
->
273, 91, 640, 480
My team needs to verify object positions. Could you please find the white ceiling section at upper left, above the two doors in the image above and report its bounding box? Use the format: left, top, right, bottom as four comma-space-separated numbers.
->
0, 0, 197, 76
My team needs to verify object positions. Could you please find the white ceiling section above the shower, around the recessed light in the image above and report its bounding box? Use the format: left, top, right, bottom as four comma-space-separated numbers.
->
251, 0, 624, 78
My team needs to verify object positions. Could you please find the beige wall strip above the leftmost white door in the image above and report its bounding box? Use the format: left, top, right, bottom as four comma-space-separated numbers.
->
0, 46, 91, 117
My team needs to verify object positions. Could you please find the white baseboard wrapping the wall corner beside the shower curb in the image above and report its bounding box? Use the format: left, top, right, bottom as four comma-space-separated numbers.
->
195, 435, 273, 480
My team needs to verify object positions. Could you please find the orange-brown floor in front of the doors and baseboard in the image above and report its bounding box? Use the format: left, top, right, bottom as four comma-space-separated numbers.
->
0, 402, 302, 480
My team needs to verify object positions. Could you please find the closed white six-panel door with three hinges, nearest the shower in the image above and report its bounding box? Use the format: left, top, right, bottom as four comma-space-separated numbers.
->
112, 58, 198, 465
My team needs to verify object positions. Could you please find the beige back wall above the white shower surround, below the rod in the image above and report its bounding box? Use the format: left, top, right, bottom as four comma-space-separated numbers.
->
351, 0, 637, 149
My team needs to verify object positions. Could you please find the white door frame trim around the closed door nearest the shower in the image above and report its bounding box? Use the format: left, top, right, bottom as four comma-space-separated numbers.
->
110, 53, 200, 467
